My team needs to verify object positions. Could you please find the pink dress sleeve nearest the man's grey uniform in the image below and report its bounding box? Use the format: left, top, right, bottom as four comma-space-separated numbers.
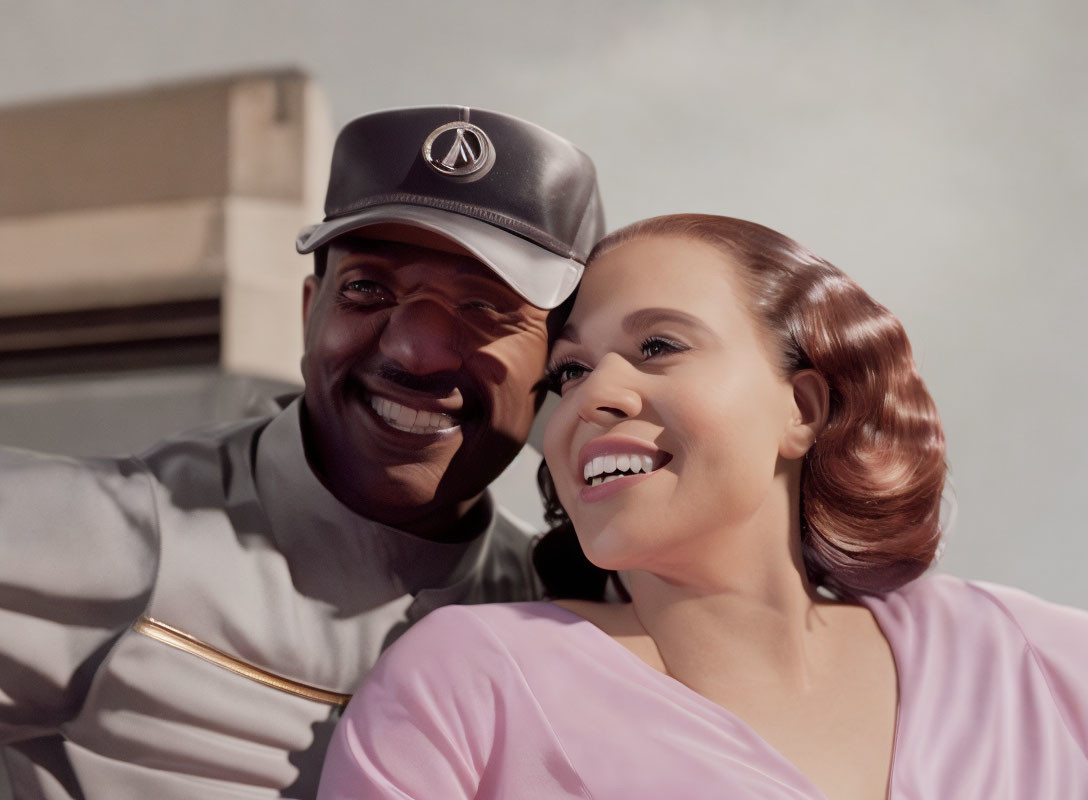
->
318, 606, 510, 800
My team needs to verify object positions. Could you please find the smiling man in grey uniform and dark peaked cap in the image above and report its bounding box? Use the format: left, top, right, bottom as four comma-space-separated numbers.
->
0, 107, 603, 799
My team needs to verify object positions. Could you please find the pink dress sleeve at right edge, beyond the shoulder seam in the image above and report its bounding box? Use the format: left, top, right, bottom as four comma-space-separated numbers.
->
972, 581, 1088, 756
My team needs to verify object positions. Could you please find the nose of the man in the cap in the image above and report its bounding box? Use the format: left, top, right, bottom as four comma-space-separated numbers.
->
380, 299, 462, 376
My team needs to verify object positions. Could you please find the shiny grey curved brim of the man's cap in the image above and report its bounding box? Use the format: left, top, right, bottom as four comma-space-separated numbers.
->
295, 204, 584, 308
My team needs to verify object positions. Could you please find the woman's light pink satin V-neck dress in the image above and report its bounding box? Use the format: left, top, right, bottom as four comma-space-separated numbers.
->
318, 576, 1088, 800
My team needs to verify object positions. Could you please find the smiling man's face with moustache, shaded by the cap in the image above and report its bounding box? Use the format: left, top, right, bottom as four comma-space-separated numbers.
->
302, 237, 548, 536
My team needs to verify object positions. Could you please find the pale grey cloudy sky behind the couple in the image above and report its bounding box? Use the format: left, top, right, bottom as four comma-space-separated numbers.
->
0, 0, 1088, 607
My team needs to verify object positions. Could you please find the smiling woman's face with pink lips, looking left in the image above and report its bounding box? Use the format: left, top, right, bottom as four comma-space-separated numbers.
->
544, 236, 798, 577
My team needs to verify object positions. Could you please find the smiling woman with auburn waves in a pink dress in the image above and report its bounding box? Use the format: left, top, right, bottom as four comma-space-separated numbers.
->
319, 216, 1088, 800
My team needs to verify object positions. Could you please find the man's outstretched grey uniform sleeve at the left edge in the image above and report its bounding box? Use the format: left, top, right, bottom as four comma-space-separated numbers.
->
0, 448, 158, 743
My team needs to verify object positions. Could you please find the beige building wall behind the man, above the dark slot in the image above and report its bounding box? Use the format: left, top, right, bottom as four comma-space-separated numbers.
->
0, 71, 332, 380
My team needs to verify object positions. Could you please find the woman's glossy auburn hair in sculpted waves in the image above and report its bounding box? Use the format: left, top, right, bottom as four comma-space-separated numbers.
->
533, 214, 947, 600
